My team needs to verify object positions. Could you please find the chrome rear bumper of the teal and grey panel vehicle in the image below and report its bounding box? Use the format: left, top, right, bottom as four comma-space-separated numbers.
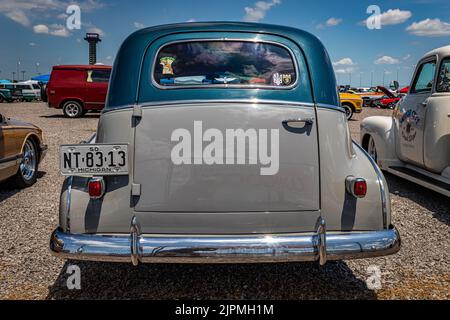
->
50, 221, 401, 265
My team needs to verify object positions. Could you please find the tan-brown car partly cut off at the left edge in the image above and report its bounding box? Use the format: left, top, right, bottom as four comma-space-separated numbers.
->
0, 114, 47, 188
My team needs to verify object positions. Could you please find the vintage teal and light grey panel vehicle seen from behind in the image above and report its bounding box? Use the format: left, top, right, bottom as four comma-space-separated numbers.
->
50, 22, 400, 265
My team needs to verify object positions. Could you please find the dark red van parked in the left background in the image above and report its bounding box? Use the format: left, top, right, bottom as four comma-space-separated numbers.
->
46, 65, 111, 118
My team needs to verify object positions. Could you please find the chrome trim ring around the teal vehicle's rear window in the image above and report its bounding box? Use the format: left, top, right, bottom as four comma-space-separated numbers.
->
150, 38, 300, 90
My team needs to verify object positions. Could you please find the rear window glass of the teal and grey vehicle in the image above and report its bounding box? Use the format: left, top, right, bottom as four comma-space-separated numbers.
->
153, 41, 298, 89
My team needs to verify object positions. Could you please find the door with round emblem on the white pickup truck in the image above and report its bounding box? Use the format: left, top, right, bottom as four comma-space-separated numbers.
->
394, 57, 436, 167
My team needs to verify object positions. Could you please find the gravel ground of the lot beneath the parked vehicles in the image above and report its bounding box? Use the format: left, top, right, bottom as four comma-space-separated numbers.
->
0, 103, 450, 299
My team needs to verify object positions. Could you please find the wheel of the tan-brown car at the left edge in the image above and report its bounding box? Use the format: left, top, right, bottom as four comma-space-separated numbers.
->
12, 139, 39, 189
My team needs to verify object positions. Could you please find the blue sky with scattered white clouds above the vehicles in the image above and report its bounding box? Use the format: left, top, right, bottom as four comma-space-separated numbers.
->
0, 0, 450, 86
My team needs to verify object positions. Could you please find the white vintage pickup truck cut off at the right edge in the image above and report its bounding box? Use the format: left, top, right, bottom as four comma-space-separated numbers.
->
361, 46, 450, 197
